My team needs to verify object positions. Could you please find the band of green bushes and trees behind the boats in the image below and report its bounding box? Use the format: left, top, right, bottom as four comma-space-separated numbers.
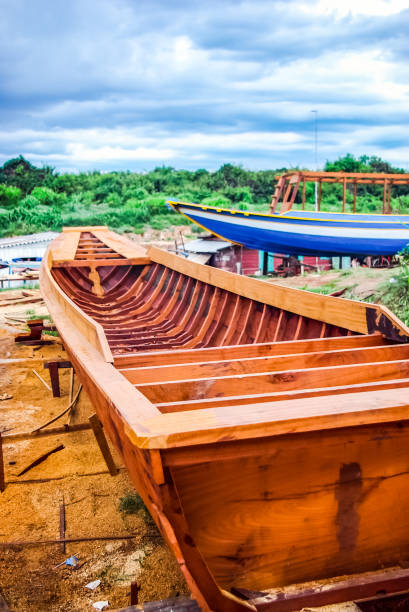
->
0, 154, 409, 237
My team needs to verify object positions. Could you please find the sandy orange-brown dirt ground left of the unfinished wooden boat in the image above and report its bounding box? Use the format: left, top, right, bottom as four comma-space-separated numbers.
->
0, 292, 188, 612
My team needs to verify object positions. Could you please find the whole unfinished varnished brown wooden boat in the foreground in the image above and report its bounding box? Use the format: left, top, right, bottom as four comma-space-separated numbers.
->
40, 227, 409, 612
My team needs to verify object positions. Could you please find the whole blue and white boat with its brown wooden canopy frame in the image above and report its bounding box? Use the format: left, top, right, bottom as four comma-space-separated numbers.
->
167, 170, 409, 257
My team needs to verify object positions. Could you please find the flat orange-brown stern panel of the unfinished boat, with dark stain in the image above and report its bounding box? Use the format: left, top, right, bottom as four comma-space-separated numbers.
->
172, 422, 409, 589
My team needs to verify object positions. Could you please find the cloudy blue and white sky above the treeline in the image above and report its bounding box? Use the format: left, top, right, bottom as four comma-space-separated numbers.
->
0, 0, 409, 172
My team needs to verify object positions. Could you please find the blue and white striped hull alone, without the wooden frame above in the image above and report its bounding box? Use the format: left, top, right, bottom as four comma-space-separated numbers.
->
167, 200, 409, 256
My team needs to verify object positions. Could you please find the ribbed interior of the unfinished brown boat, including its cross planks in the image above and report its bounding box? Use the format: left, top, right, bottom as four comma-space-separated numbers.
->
52, 231, 409, 412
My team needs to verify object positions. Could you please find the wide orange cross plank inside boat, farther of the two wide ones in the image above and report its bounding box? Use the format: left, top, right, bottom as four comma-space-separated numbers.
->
119, 344, 409, 384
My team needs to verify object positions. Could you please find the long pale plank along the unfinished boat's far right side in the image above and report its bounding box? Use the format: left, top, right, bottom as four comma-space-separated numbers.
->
148, 247, 380, 335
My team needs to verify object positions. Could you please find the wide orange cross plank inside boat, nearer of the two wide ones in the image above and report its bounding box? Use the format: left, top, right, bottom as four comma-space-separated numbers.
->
136, 359, 409, 403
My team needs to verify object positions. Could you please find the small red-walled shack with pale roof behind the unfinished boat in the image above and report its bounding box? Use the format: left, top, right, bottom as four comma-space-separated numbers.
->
184, 236, 259, 275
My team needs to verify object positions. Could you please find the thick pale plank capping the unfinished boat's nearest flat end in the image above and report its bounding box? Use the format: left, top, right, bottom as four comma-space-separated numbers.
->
134, 388, 409, 449
